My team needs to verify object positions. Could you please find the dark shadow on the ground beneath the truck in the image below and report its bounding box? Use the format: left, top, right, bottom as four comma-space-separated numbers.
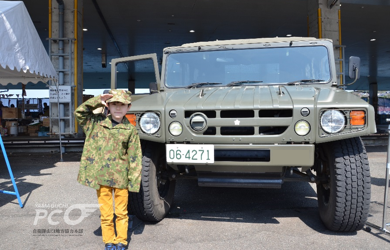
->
129, 180, 366, 236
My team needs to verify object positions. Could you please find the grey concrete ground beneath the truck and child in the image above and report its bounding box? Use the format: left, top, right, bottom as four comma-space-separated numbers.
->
0, 147, 390, 250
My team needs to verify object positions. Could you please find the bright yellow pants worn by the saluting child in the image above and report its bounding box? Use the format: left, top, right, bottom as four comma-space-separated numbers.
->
97, 186, 129, 245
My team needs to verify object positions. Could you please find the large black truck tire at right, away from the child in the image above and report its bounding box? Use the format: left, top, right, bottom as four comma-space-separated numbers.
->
315, 137, 371, 232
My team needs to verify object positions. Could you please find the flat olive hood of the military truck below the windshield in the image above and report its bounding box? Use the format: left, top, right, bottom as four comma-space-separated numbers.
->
166, 86, 316, 110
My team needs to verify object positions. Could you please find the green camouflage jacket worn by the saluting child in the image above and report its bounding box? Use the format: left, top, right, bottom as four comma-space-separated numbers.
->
75, 96, 142, 192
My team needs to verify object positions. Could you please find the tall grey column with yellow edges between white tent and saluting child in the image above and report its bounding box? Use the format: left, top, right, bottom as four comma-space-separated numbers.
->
49, 0, 83, 135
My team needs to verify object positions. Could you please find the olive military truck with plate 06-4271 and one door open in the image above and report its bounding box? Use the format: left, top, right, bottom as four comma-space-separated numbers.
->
111, 37, 376, 232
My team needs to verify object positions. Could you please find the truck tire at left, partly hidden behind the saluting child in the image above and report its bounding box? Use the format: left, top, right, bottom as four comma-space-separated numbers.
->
128, 142, 176, 223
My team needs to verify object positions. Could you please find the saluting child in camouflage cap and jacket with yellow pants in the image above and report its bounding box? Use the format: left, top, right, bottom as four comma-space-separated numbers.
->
75, 90, 142, 250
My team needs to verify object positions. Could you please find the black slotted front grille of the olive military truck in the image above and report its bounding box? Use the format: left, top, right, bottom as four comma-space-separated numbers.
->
185, 109, 293, 136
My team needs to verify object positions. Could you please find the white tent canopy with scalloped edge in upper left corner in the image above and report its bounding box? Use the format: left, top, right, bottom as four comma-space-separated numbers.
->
0, 1, 58, 85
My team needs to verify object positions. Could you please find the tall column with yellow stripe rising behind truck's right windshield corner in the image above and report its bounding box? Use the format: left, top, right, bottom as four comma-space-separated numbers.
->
307, 0, 345, 84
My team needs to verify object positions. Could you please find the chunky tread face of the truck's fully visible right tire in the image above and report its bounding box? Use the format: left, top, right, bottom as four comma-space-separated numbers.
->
321, 137, 371, 232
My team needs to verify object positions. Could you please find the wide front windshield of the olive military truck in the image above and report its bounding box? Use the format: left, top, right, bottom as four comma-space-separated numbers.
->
165, 46, 331, 88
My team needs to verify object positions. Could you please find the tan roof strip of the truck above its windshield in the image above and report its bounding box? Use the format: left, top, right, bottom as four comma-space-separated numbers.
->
166, 37, 332, 49
